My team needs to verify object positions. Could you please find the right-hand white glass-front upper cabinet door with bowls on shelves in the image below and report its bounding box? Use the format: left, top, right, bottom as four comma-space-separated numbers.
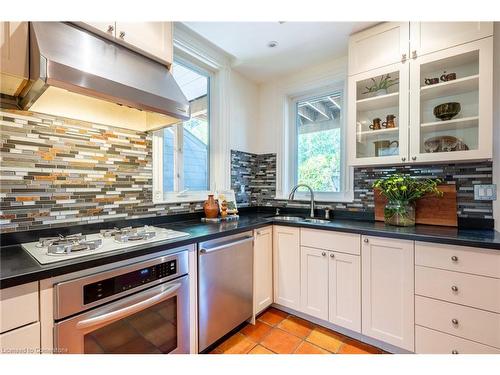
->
409, 38, 493, 162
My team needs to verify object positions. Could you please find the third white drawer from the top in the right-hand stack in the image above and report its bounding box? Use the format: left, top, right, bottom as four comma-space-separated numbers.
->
415, 296, 500, 348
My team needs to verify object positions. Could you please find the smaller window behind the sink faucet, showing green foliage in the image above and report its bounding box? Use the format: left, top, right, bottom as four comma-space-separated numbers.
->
288, 88, 349, 201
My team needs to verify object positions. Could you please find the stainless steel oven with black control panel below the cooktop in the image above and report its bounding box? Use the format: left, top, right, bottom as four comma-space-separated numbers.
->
54, 250, 190, 354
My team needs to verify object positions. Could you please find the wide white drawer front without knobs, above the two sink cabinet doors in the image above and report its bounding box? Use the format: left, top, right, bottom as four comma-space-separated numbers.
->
300, 228, 361, 255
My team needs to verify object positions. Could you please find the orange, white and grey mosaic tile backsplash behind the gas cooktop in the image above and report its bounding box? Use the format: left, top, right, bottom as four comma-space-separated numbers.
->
0, 111, 203, 232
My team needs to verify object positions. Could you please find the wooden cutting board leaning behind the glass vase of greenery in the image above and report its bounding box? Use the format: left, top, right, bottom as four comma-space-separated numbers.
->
373, 185, 458, 227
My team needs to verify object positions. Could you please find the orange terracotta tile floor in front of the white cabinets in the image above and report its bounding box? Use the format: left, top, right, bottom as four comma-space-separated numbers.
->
211, 308, 385, 354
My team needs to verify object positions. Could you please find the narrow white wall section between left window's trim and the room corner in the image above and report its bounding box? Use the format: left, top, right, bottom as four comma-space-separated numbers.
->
229, 69, 260, 152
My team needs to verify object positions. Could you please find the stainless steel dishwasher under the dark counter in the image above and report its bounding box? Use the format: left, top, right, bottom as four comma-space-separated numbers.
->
198, 232, 253, 352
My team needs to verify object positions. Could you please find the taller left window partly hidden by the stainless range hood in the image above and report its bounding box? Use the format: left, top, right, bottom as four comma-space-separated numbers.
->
156, 60, 210, 200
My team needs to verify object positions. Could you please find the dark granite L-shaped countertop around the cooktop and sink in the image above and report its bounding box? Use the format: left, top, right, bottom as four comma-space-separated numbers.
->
0, 212, 500, 289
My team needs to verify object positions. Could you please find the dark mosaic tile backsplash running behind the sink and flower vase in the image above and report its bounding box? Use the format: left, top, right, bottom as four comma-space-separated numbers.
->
231, 151, 493, 219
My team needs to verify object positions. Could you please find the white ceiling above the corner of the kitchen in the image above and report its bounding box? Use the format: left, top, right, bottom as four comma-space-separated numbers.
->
184, 22, 376, 82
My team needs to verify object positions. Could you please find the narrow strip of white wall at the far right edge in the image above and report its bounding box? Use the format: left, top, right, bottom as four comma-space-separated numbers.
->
493, 22, 500, 230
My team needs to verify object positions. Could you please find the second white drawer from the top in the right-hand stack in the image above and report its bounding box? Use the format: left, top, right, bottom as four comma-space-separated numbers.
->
415, 266, 500, 313
